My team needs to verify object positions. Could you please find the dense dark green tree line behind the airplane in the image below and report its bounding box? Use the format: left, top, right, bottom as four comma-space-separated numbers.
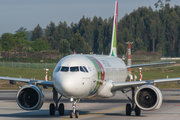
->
0, 0, 180, 57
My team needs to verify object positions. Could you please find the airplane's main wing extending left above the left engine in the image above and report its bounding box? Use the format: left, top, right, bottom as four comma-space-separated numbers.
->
0, 76, 54, 87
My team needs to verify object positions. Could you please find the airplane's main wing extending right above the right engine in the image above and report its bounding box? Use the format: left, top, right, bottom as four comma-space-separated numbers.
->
111, 77, 180, 91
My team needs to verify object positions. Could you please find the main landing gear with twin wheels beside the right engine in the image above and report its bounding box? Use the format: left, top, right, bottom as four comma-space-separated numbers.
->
121, 87, 141, 116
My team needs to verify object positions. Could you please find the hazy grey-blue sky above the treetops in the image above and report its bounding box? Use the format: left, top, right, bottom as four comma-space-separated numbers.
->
0, 0, 180, 35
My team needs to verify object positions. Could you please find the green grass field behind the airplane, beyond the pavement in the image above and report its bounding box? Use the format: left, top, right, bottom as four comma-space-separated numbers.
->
0, 66, 180, 90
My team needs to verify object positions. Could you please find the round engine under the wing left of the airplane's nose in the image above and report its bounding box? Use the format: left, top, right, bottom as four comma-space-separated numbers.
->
16, 84, 44, 110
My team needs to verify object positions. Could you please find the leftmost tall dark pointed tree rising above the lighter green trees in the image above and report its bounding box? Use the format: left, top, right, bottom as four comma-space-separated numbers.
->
31, 24, 43, 41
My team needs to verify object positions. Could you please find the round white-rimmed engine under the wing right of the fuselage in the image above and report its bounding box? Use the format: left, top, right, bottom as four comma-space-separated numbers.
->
135, 85, 163, 110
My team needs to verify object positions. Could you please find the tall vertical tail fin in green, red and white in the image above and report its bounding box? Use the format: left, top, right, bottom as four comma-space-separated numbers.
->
109, 1, 118, 57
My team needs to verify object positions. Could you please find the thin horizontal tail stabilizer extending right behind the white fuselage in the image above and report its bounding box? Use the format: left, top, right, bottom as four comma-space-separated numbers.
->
127, 61, 176, 68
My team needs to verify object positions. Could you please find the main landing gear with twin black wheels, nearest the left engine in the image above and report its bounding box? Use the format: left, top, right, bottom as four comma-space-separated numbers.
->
49, 88, 64, 115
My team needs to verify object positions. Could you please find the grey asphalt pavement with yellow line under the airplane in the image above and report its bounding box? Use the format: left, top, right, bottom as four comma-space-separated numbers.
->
0, 89, 180, 120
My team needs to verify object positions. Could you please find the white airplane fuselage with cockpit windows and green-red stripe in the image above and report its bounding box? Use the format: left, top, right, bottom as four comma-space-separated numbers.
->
53, 54, 127, 98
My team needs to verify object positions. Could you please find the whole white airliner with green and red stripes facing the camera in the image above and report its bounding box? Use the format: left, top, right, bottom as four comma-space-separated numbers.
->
0, 1, 180, 118
